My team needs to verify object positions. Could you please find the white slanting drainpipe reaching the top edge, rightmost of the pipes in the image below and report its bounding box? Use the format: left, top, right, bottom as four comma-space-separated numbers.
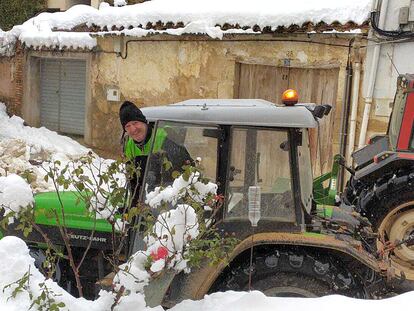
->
358, 0, 388, 148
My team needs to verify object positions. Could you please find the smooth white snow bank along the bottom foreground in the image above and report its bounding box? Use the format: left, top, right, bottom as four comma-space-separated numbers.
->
0, 236, 414, 311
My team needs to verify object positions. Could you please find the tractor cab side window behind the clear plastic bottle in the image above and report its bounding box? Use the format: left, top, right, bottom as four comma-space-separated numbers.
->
225, 128, 295, 222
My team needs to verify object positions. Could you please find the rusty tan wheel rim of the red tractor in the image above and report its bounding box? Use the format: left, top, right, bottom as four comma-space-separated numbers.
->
374, 194, 414, 281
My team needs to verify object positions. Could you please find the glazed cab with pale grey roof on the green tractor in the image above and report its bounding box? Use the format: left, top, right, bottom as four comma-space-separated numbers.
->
141, 99, 317, 237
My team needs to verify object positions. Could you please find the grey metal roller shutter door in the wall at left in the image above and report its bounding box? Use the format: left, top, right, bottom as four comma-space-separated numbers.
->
40, 59, 86, 135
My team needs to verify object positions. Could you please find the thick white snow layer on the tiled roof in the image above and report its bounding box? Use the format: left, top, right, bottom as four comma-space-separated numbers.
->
91, 0, 371, 29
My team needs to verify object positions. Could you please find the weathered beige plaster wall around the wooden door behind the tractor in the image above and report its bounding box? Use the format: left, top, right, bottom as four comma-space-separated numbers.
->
91, 36, 356, 152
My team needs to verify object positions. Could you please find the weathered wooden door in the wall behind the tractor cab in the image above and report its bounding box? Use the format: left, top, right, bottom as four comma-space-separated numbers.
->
235, 64, 339, 175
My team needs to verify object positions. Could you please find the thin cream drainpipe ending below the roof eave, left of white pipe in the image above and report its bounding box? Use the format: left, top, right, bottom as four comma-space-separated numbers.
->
346, 46, 361, 165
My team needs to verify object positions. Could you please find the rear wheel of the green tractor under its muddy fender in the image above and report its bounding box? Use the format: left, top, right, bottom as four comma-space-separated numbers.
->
210, 249, 366, 298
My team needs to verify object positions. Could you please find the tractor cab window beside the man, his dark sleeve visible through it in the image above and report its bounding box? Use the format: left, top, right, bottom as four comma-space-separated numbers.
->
143, 121, 219, 193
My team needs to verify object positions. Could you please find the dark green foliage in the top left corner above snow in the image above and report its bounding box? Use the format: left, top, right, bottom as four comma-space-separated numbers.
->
0, 0, 47, 31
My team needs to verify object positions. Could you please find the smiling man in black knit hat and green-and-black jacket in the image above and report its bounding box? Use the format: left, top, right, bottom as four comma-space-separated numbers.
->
119, 101, 192, 206
